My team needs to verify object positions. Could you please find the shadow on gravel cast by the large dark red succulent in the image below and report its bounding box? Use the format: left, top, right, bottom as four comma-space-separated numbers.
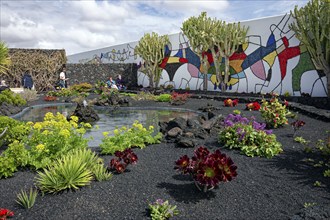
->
157, 182, 215, 204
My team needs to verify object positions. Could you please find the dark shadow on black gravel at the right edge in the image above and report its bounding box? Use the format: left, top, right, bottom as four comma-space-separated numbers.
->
267, 150, 330, 192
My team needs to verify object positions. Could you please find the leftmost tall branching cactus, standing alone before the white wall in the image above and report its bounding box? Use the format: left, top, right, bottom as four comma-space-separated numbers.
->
134, 32, 169, 88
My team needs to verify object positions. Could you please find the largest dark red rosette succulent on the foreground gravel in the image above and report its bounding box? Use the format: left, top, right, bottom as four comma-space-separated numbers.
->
174, 147, 237, 192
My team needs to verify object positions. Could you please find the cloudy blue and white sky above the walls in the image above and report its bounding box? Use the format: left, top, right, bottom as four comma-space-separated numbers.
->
0, 0, 308, 55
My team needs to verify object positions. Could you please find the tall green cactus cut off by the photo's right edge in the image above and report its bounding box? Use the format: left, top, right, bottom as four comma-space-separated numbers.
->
289, 0, 330, 97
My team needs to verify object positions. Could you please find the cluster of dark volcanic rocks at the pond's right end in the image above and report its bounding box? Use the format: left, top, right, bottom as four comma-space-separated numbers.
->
159, 105, 223, 148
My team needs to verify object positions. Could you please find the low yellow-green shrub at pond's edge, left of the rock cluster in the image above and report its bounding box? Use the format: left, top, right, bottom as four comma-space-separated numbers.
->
100, 121, 162, 154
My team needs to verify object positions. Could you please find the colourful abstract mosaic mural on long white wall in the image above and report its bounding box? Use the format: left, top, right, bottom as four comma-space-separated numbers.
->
68, 15, 328, 97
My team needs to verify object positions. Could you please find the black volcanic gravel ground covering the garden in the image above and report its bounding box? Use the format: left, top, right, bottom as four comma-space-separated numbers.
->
0, 96, 330, 220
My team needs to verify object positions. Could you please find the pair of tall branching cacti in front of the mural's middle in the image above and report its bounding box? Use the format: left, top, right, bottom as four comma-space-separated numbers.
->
181, 12, 247, 90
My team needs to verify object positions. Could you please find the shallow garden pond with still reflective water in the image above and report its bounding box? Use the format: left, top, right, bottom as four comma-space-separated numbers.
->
13, 103, 201, 147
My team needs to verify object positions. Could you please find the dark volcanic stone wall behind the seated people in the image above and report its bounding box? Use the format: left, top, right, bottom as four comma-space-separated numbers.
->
66, 63, 138, 89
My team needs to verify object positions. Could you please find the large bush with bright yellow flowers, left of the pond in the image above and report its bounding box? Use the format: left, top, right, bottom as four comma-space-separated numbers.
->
23, 112, 91, 169
